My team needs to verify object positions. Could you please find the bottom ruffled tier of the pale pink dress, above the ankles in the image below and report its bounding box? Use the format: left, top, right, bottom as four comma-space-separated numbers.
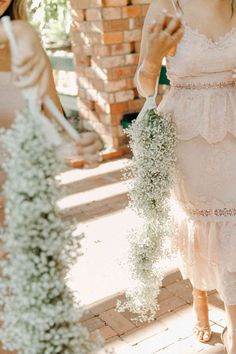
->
172, 216, 236, 305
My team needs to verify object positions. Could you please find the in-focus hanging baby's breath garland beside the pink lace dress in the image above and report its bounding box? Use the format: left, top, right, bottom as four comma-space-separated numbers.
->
117, 107, 177, 322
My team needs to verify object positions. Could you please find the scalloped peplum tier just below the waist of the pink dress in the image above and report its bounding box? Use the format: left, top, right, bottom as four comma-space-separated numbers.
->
158, 88, 236, 144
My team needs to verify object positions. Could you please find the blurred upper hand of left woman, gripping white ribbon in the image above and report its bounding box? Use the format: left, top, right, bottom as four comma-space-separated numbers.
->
9, 21, 49, 99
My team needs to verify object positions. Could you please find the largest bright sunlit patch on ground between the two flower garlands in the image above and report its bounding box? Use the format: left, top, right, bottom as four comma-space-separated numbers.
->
67, 211, 137, 304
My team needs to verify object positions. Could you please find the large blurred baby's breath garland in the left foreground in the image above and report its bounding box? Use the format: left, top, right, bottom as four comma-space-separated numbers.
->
0, 109, 103, 354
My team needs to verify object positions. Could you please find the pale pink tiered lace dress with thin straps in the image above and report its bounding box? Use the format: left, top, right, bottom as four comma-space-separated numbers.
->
159, 25, 236, 305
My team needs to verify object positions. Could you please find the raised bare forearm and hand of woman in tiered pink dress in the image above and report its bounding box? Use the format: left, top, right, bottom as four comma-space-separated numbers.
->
135, 0, 183, 96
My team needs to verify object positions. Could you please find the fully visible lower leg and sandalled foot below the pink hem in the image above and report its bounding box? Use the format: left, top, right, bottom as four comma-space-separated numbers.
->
193, 289, 211, 343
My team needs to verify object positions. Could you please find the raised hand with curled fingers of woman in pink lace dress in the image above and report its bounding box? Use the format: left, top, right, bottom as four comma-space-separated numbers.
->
144, 11, 184, 71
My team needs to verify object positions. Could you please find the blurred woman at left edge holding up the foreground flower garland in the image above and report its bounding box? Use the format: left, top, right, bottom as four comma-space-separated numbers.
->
0, 0, 101, 216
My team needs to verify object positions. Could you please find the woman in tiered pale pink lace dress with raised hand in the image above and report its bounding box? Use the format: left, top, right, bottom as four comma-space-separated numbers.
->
137, 0, 236, 354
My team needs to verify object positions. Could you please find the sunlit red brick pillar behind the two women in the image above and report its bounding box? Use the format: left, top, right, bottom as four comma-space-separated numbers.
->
70, 0, 151, 149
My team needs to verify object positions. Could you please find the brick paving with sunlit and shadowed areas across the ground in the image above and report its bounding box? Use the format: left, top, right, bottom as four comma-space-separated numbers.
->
56, 159, 228, 354
